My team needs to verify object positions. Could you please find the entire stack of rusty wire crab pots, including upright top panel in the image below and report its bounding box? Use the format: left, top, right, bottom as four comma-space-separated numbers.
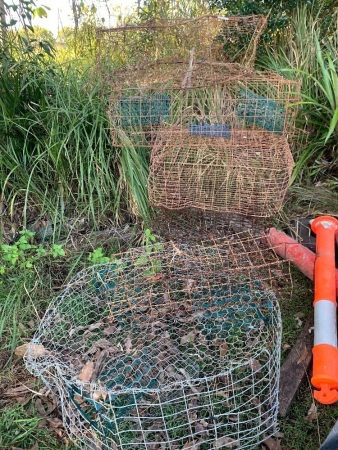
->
99, 15, 300, 217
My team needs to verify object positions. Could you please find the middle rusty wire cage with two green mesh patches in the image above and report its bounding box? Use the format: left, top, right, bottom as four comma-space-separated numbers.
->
109, 61, 300, 136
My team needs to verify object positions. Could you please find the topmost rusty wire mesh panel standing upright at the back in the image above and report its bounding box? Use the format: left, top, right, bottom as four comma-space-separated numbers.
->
97, 15, 267, 68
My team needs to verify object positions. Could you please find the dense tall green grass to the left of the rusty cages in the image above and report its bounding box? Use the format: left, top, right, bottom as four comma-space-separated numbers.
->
0, 61, 150, 232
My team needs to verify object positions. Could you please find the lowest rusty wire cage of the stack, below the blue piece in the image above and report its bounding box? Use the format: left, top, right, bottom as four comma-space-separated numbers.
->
149, 129, 293, 217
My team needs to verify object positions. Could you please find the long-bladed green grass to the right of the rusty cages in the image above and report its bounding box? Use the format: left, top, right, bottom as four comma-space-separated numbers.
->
258, 5, 338, 182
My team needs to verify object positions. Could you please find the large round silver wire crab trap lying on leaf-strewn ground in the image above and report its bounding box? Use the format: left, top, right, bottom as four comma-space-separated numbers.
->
26, 236, 281, 450
